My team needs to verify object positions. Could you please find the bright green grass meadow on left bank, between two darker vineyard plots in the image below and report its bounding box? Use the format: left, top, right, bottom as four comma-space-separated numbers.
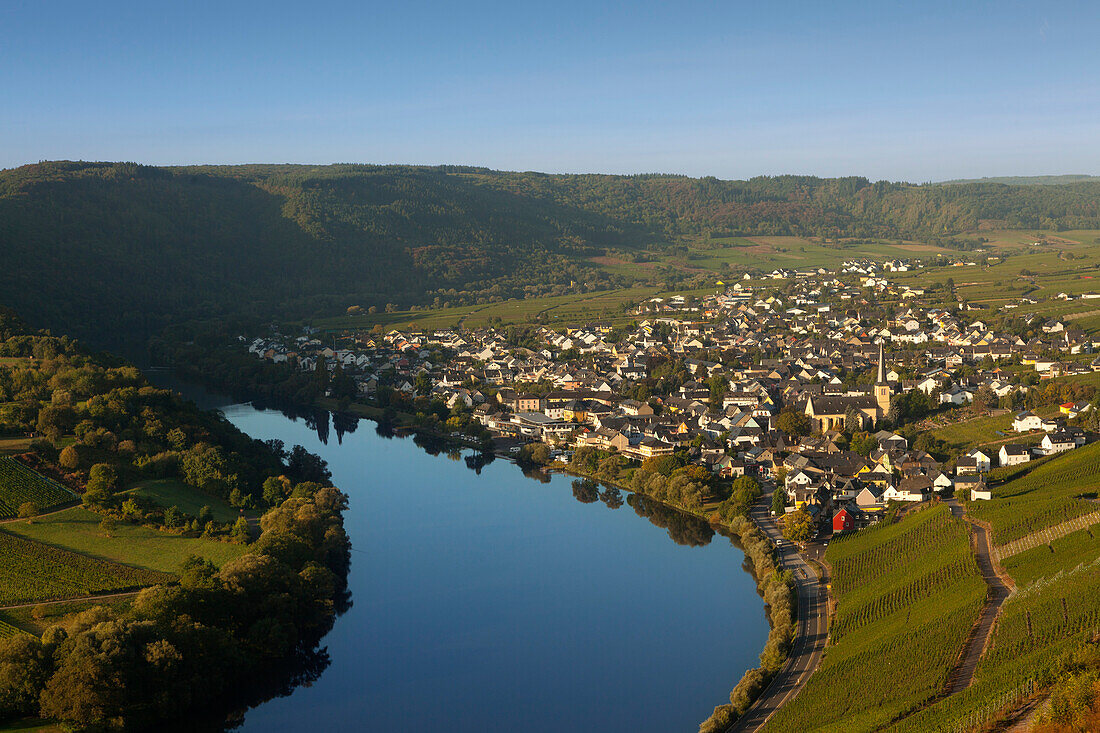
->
4, 506, 248, 573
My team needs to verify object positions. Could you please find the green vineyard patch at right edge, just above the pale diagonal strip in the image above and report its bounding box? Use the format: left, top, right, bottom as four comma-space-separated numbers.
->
969, 435, 1100, 545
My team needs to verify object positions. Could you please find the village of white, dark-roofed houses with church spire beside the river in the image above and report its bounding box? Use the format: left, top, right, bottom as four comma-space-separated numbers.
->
241, 261, 1100, 532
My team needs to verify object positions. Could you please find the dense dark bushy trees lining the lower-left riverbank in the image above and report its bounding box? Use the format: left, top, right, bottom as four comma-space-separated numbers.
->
0, 485, 350, 730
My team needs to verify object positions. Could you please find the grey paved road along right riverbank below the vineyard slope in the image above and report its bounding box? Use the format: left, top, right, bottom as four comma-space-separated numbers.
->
729, 495, 828, 733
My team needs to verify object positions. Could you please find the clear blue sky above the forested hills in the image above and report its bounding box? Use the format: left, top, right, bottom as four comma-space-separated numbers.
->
0, 0, 1100, 182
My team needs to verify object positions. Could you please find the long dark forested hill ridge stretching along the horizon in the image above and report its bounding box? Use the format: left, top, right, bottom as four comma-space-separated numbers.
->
0, 162, 1100, 348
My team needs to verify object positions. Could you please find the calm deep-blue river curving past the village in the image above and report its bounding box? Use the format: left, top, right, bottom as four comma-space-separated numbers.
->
157, 379, 768, 733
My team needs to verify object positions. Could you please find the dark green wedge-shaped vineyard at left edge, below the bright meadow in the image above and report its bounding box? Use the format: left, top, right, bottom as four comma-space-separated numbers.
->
0, 532, 172, 605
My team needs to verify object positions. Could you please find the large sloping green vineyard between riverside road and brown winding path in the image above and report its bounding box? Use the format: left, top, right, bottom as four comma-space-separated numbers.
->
763, 505, 987, 733
